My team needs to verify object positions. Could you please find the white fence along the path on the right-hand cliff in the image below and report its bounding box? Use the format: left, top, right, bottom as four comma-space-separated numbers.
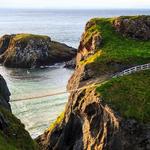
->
112, 63, 150, 78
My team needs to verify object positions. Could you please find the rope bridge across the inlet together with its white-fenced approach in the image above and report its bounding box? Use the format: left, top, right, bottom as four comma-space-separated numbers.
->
10, 63, 150, 103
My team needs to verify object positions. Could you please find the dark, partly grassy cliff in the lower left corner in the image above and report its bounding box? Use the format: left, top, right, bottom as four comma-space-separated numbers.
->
0, 76, 38, 150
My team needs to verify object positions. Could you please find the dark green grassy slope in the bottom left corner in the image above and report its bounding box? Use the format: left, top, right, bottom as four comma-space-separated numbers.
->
0, 107, 38, 150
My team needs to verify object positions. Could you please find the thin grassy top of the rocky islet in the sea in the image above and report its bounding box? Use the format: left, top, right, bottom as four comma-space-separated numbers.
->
14, 33, 49, 41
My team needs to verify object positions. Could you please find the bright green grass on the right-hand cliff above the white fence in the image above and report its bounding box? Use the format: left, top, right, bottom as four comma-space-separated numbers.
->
84, 16, 150, 73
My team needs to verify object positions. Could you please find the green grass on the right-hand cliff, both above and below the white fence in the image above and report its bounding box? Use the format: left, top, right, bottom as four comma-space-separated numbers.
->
82, 16, 150, 123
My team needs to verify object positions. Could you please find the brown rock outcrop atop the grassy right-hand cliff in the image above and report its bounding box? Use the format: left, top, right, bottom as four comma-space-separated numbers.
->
114, 16, 150, 40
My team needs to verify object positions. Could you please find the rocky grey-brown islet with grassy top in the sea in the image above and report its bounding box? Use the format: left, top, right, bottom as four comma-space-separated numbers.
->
0, 34, 76, 68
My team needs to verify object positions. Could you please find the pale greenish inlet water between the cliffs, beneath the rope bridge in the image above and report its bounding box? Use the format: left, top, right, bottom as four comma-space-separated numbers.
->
0, 65, 72, 137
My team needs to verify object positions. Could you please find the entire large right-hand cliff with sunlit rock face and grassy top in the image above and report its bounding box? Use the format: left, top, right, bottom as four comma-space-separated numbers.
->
36, 16, 150, 150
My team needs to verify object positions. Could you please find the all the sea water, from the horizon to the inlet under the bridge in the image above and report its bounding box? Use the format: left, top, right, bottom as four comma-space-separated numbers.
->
0, 9, 150, 137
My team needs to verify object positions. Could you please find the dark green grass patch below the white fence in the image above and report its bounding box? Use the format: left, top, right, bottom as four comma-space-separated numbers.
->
97, 70, 150, 123
